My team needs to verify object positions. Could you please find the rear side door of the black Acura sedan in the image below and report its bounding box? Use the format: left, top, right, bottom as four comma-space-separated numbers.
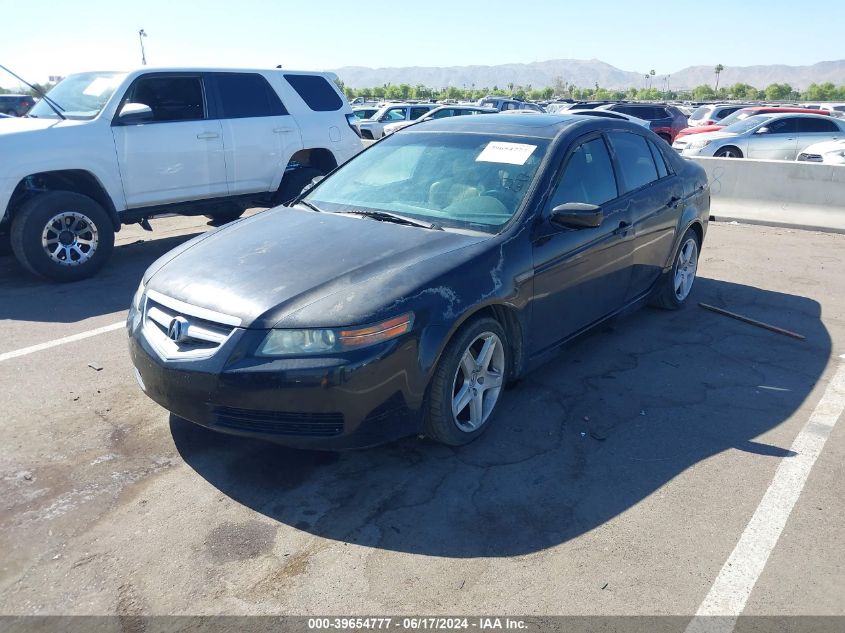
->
607, 132, 684, 300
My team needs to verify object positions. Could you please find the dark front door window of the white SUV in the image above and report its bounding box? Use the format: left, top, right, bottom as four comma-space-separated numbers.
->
127, 75, 205, 123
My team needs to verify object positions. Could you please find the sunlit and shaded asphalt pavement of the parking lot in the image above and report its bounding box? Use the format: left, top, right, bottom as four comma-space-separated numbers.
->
0, 218, 845, 615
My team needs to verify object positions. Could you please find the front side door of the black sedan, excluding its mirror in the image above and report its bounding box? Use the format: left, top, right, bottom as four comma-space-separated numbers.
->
531, 134, 631, 354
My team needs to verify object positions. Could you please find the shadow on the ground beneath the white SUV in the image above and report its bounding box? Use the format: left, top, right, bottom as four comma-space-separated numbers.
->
0, 233, 203, 323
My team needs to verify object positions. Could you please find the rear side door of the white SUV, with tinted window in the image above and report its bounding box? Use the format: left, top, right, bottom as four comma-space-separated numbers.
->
205, 72, 294, 195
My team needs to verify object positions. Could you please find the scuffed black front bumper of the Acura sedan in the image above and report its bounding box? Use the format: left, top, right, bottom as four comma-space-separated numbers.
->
129, 314, 425, 450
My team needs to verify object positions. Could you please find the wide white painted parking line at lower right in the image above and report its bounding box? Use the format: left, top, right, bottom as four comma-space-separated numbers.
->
686, 354, 845, 633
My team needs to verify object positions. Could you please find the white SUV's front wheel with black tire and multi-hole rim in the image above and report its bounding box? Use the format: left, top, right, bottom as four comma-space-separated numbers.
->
11, 191, 114, 281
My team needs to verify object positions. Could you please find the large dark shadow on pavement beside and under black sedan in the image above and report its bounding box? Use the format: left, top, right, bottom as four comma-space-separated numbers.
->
171, 278, 831, 557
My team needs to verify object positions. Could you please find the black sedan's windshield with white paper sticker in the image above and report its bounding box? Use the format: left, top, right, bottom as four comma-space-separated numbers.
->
305, 132, 548, 233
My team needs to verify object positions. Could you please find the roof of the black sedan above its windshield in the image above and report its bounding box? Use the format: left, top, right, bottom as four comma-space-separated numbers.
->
402, 112, 645, 139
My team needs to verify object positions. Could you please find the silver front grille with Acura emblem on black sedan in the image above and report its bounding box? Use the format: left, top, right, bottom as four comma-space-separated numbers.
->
143, 290, 240, 359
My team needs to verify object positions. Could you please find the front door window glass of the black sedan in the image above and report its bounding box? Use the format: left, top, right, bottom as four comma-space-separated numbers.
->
551, 138, 617, 208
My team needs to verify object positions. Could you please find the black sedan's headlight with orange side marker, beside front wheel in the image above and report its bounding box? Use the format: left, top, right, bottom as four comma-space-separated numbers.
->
256, 312, 414, 356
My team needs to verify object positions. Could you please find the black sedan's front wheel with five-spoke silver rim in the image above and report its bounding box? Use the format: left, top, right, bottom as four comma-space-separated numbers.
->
425, 317, 511, 446
